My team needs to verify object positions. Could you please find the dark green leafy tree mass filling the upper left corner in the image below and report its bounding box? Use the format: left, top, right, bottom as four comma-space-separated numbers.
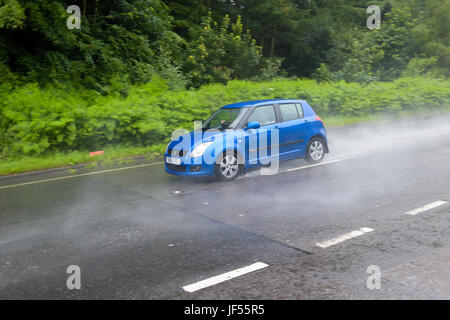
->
0, 0, 185, 89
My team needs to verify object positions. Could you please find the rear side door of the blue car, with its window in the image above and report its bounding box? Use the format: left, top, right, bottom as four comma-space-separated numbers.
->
278, 103, 309, 160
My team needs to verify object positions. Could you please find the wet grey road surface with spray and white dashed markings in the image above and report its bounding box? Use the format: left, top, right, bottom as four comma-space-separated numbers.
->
0, 117, 450, 299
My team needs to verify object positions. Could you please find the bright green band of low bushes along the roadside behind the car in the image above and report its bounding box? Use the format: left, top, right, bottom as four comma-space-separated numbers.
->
0, 78, 450, 157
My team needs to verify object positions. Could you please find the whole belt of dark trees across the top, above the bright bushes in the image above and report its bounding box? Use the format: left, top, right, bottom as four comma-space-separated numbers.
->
0, 0, 450, 93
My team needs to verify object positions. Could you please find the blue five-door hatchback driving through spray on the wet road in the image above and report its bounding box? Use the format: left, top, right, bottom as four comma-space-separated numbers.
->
164, 99, 329, 180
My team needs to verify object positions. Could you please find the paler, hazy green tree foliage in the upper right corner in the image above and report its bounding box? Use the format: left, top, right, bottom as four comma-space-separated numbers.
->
314, 0, 450, 82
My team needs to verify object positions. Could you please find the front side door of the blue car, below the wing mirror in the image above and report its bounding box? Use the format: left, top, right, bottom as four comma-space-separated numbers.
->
246, 104, 279, 166
